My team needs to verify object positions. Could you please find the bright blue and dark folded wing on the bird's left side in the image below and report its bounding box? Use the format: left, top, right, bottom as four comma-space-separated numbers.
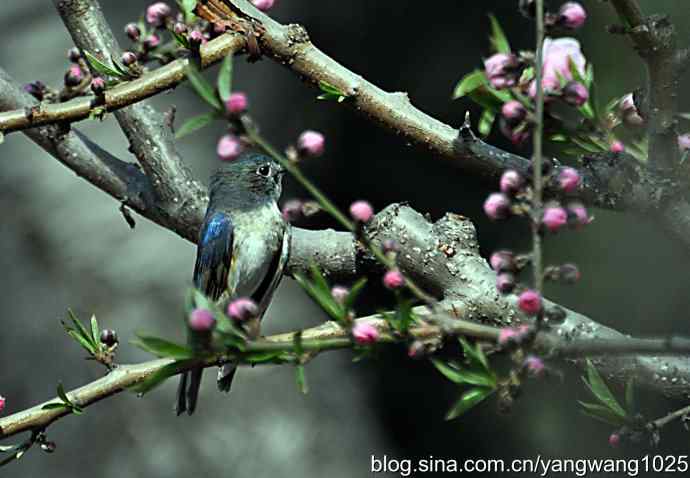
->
194, 212, 234, 300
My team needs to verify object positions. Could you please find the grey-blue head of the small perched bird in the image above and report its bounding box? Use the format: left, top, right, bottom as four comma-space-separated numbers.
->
209, 152, 285, 202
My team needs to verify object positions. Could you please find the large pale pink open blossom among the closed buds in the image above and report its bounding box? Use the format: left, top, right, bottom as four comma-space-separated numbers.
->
529, 38, 587, 98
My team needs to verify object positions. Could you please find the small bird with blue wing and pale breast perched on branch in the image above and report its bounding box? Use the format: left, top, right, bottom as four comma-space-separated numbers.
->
175, 152, 290, 415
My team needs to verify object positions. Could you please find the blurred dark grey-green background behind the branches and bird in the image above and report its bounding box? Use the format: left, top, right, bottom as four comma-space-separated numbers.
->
0, 0, 690, 478
